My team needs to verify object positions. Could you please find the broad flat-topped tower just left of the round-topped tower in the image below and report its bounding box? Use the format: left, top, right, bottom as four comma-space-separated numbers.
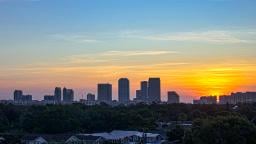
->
98, 83, 112, 102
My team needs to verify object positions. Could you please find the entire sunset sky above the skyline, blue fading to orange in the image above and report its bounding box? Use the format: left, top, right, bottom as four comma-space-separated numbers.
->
0, 0, 256, 102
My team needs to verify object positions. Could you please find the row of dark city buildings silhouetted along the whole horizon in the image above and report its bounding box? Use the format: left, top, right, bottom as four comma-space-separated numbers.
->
5, 77, 256, 105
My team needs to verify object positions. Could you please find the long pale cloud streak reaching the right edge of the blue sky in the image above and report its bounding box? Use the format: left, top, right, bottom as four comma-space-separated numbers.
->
118, 29, 256, 44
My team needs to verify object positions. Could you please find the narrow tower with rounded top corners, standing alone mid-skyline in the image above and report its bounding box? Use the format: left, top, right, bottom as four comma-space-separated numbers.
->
118, 78, 130, 103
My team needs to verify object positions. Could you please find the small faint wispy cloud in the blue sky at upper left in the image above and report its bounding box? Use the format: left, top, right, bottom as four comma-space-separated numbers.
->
51, 34, 99, 43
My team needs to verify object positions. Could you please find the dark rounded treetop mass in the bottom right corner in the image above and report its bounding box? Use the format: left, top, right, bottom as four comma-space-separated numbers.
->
184, 115, 256, 144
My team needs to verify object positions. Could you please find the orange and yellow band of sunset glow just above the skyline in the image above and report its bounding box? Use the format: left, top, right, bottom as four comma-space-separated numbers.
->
0, 62, 256, 100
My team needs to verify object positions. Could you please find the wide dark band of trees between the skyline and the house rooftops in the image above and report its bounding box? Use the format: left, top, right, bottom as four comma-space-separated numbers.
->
0, 104, 256, 134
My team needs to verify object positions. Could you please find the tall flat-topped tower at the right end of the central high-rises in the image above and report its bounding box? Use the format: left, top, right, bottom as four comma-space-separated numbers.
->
148, 78, 161, 103
